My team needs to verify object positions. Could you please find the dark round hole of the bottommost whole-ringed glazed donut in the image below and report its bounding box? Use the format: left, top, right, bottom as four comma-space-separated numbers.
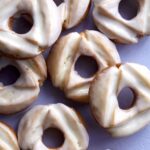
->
43, 128, 65, 148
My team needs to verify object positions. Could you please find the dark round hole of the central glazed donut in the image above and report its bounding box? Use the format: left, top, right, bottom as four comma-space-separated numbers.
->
75, 55, 98, 78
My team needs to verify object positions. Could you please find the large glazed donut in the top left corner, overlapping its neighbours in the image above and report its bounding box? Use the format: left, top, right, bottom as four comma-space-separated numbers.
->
0, 0, 62, 59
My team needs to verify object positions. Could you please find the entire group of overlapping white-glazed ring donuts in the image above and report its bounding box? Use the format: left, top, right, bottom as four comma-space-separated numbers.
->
0, 0, 150, 150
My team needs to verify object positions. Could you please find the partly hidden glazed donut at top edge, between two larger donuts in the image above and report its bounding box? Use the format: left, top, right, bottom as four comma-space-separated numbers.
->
59, 0, 91, 29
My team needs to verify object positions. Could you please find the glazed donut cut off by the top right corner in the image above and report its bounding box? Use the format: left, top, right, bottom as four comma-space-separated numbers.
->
93, 0, 150, 44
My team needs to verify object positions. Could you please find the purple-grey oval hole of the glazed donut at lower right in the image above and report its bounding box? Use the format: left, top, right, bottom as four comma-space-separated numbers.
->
118, 87, 136, 110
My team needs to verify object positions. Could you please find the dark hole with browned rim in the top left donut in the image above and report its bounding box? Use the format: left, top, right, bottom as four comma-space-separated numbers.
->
9, 12, 33, 34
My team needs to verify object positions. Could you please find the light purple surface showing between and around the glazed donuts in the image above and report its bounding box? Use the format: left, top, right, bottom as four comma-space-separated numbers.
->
0, 1, 150, 150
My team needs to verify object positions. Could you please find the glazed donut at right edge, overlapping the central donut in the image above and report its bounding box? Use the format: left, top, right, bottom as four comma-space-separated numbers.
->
90, 63, 150, 137
